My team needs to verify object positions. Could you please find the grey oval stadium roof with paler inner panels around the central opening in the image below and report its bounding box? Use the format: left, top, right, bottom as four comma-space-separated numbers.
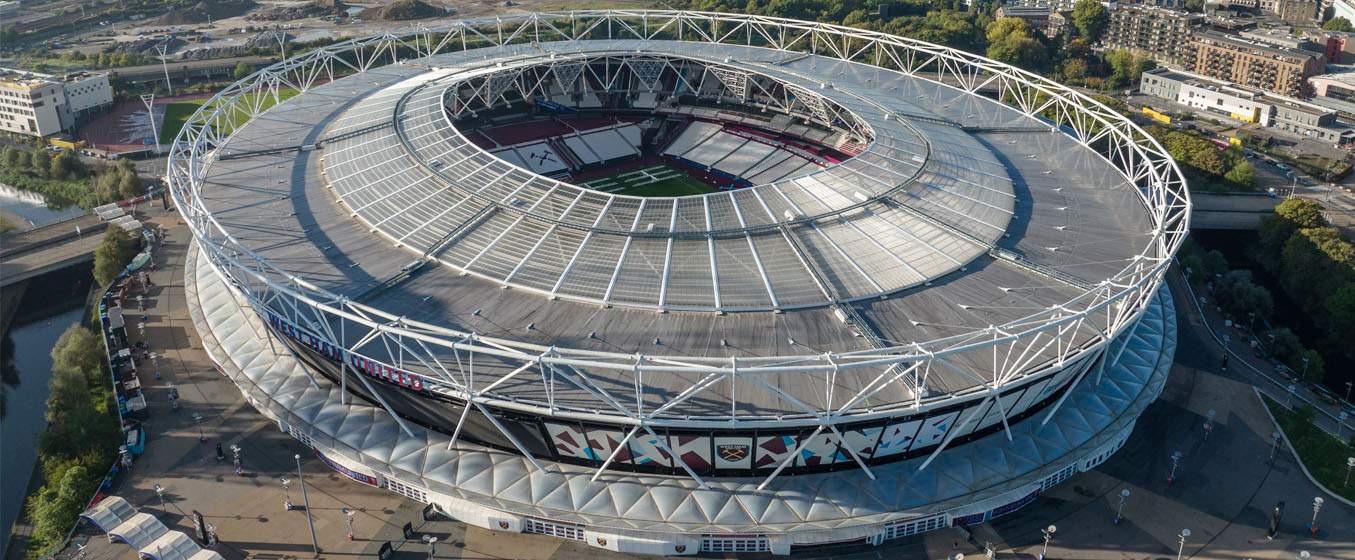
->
202, 41, 1152, 412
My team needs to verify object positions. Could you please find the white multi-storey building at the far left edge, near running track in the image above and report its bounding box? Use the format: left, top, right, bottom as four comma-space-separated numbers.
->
0, 68, 112, 137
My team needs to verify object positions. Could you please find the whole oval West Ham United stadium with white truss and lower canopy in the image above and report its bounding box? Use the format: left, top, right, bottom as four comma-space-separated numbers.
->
167, 11, 1190, 555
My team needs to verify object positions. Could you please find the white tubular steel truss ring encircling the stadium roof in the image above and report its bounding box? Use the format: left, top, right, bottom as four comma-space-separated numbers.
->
167, 9, 1190, 485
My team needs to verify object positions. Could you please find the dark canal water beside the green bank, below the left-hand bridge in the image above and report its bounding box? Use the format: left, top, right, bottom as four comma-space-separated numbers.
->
0, 264, 92, 551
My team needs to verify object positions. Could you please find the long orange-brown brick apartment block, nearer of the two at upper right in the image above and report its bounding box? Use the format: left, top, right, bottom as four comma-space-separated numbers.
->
1192, 31, 1327, 98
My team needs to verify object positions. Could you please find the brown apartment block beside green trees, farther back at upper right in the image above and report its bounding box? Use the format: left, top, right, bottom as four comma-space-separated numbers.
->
1104, 4, 1205, 68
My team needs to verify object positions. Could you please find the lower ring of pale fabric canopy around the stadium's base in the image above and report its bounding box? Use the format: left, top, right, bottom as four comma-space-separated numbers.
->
186, 246, 1176, 534
